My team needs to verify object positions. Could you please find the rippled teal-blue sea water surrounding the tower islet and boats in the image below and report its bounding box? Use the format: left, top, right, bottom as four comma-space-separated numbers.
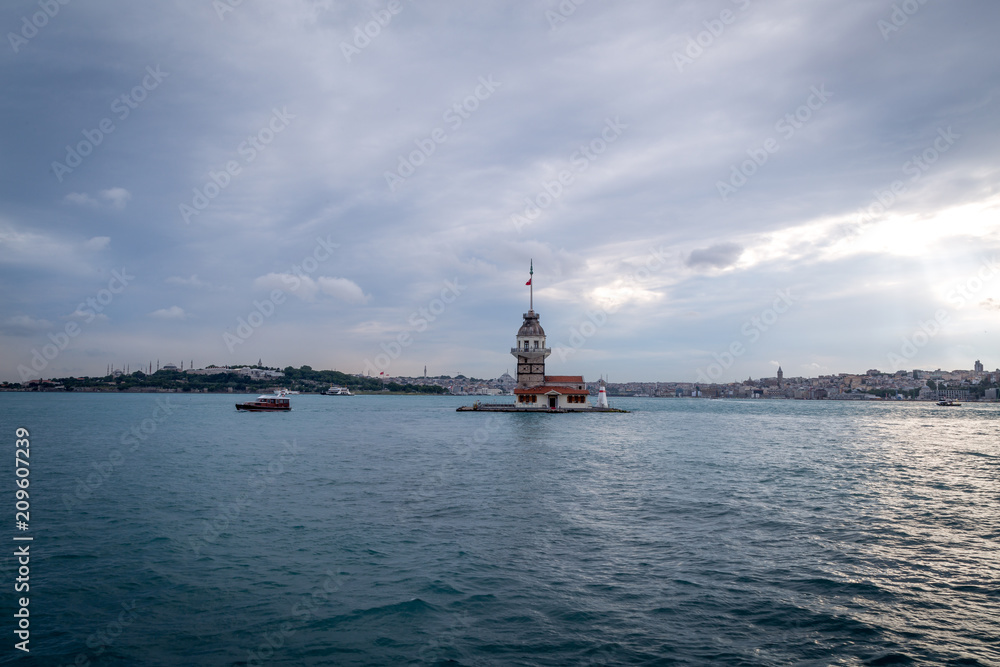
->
0, 394, 1000, 665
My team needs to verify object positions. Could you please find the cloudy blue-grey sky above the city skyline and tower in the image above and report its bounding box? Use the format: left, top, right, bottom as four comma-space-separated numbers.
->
0, 0, 1000, 382
